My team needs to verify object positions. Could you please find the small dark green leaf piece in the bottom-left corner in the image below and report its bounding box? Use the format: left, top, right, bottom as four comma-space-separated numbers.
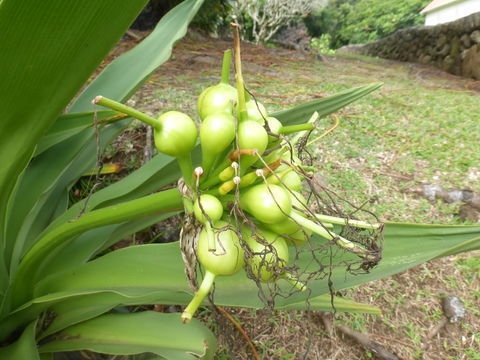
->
0, 321, 40, 360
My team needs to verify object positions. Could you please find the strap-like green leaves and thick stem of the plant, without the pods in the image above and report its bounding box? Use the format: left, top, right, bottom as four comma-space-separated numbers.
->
0, 0, 480, 360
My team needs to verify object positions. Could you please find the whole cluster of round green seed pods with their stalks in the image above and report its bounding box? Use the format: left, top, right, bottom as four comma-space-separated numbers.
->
94, 38, 378, 322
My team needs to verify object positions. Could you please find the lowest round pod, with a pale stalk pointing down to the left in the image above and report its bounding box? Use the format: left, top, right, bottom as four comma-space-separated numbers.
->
197, 221, 244, 275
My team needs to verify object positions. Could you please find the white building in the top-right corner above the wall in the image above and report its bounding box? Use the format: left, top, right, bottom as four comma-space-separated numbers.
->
420, 0, 480, 25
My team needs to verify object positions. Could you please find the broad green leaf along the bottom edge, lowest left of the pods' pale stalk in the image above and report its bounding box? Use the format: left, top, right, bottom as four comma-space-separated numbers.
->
40, 311, 216, 360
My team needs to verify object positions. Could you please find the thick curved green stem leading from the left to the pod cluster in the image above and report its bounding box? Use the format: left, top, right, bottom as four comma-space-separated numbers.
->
10, 189, 182, 309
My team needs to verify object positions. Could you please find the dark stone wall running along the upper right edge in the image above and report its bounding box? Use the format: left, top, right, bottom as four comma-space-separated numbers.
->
337, 12, 480, 80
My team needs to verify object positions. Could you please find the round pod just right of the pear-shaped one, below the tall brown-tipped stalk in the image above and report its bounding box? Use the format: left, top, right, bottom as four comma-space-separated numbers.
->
238, 120, 268, 174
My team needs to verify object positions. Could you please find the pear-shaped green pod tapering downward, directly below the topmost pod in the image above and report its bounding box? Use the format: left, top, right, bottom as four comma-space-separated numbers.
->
200, 113, 235, 175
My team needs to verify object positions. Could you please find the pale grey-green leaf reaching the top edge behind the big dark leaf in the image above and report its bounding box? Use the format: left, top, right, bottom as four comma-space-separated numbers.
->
70, 0, 203, 112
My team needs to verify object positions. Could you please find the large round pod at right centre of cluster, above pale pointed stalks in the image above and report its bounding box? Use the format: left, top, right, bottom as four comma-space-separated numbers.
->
240, 184, 292, 224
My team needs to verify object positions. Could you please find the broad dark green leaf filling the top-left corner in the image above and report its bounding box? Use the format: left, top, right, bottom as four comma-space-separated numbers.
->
0, 0, 147, 263
